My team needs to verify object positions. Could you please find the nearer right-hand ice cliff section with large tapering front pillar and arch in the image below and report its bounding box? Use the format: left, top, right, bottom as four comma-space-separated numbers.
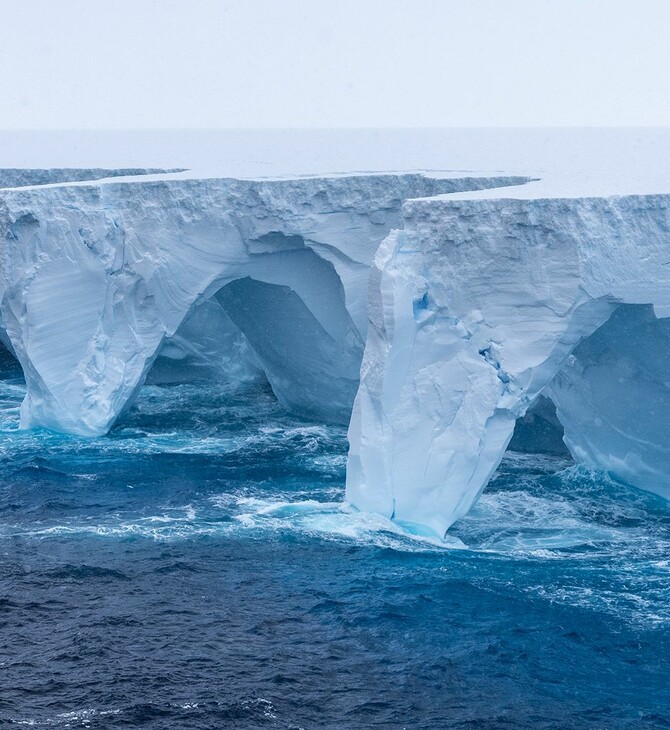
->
347, 196, 670, 534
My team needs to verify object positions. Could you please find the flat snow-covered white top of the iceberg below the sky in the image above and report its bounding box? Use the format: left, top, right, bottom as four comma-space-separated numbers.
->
0, 128, 670, 199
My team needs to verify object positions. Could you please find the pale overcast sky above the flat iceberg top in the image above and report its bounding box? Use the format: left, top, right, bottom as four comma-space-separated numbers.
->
0, 0, 670, 130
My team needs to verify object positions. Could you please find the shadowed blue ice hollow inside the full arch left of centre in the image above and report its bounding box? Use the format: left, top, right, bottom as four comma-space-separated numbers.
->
148, 242, 363, 424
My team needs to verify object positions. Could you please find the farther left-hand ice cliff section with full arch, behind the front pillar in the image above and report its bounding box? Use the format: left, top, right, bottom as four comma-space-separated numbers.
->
0, 174, 526, 436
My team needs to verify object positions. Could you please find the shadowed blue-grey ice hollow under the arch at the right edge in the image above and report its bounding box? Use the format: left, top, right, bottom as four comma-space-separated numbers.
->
509, 304, 670, 480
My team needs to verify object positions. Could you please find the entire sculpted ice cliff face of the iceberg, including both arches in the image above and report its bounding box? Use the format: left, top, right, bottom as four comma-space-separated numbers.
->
0, 171, 670, 534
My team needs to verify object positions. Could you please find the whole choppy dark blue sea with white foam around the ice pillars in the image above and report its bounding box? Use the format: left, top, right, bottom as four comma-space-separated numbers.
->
0, 366, 670, 729
